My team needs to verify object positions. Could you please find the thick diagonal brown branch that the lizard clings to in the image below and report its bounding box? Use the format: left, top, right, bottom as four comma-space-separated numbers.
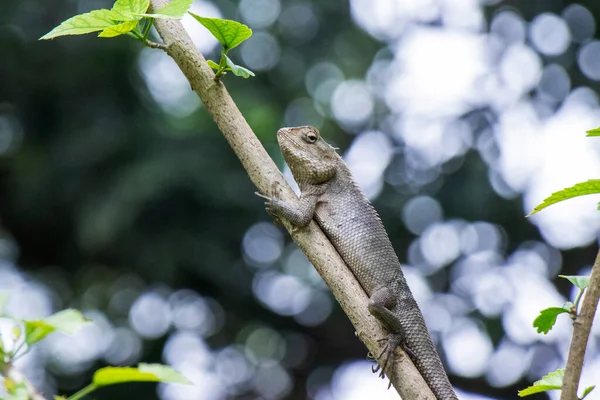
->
145, 0, 435, 400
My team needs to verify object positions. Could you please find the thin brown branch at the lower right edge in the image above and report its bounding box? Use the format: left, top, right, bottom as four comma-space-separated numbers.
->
560, 251, 600, 400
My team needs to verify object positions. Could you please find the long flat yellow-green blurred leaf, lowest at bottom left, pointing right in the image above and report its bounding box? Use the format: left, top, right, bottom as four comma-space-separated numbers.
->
92, 364, 191, 386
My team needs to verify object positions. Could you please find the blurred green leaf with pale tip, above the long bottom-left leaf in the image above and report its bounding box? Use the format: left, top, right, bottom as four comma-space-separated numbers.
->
23, 309, 89, 346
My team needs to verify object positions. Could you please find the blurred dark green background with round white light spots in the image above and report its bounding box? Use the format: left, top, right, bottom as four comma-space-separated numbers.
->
0, 0, 600, 400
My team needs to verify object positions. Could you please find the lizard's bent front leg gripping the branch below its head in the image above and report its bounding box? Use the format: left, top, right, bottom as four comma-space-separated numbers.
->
256, 182, 319, 228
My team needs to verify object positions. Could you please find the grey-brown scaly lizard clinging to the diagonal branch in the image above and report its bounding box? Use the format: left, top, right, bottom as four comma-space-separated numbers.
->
262, 126, 458, 400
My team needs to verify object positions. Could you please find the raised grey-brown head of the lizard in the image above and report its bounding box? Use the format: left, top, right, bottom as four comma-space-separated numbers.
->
277, 126, 340, 187
